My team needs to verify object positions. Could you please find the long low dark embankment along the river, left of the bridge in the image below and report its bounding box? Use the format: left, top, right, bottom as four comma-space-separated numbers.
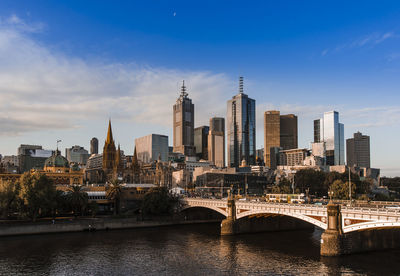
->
0, 218, 220, 237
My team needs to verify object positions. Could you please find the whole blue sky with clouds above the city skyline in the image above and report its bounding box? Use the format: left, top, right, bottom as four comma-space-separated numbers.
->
0, 1, 400, 175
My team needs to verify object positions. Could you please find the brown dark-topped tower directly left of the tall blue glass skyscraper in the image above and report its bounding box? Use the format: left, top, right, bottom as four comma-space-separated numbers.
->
208, 117, 225, 168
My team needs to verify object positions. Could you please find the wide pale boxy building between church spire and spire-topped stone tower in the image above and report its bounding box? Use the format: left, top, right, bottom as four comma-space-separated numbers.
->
135, 134, 168, 163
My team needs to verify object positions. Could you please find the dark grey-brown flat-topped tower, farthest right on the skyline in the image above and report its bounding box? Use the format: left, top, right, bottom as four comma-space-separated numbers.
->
346, 132, 371, 168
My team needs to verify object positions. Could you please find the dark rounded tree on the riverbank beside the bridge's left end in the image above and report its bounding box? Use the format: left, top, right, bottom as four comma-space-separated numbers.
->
142, 187, 177, 215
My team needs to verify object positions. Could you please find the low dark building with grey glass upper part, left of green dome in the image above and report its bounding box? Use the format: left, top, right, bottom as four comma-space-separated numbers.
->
18, 145, 53, 173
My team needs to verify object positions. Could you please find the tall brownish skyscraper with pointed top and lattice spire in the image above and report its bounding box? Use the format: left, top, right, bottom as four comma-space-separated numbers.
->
173, 81, 195, 156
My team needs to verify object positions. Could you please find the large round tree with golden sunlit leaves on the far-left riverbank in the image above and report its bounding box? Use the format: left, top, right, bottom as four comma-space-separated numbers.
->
18, 172, 57, 221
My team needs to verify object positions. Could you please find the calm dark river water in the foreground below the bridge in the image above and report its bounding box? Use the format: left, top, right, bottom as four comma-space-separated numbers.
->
0, 224, 400, 275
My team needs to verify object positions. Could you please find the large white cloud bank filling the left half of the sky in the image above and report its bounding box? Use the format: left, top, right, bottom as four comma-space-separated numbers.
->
0, 15, 233, 135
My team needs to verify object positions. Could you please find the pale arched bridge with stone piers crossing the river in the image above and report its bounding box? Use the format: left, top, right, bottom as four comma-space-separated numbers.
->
181, 198, 400, 256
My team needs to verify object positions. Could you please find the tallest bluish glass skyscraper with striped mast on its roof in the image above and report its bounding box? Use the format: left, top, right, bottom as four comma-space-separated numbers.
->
226, 77, 256, 167
